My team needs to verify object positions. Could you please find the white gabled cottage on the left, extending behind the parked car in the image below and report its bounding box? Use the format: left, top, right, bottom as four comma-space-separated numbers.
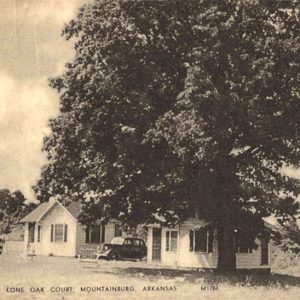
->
21, 200, 122, 256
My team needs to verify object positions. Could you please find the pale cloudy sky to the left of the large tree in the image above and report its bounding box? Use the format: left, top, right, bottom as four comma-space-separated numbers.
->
0, 0, 87, 201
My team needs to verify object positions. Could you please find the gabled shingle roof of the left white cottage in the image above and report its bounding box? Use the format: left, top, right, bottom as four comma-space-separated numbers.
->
20, 200, 81, 223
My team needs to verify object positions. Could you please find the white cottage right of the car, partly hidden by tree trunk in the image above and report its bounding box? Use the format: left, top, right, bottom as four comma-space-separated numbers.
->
147, 218, 270, 270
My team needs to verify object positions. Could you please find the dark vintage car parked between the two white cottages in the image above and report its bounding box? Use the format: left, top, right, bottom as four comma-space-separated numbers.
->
97, 237, 147, 260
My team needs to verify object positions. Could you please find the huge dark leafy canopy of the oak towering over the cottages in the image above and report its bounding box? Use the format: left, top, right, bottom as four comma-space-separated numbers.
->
35, 0, 300, 270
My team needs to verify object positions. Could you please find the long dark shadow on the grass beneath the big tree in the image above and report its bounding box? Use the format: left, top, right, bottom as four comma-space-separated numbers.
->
89, 266, 300, 289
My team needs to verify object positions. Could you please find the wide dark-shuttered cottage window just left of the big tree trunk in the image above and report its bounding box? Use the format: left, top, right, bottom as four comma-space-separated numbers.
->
190, 227, 213, 253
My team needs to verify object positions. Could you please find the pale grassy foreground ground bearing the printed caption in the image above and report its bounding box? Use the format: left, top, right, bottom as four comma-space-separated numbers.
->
0, 255, 300, 300
